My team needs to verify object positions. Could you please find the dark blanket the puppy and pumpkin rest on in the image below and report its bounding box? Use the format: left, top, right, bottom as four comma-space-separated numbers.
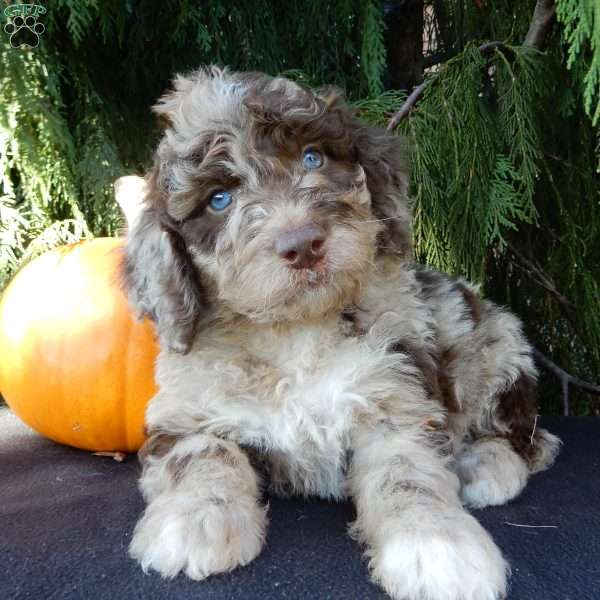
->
0, 409, 600, 600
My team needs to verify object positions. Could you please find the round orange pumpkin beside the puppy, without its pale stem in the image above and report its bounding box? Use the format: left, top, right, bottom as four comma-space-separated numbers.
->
0, 238, 158, 452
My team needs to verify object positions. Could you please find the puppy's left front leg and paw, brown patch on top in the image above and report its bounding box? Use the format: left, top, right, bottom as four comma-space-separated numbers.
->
129, 433, 267, 579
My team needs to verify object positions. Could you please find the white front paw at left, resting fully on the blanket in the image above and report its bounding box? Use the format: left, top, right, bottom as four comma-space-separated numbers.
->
129, 497, 267, 580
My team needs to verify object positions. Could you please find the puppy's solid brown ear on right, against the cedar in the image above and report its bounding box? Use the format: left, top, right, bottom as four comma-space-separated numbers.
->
354, 121, 412, 259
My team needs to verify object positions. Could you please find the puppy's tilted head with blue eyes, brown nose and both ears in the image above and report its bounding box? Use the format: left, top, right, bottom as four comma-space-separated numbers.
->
125, 68, 410, 352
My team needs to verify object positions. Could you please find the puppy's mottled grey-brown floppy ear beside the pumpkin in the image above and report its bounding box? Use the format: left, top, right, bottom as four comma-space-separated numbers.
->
123, 165, 208, 354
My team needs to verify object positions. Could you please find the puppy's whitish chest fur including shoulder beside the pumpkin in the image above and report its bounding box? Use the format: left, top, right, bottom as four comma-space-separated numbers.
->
147, 318, 397, 497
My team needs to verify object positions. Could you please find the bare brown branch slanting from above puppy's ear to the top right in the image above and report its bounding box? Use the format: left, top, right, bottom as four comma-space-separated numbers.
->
387, 0, 554, 131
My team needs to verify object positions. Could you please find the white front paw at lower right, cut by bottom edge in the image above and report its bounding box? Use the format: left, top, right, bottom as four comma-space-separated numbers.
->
371, 513, 509, 600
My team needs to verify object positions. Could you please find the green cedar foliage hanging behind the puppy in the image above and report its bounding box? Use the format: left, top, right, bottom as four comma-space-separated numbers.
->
0, 0, 600, 413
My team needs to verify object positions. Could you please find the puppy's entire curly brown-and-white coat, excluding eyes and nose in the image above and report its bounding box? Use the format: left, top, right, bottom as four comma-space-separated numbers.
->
124, 68, 559, 600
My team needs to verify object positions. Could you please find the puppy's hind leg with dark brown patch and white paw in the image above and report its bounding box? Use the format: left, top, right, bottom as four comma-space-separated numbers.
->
455, 332, 561, 508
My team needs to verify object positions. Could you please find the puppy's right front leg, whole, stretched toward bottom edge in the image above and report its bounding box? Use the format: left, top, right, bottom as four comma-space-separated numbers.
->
349, 421, 508, 600
